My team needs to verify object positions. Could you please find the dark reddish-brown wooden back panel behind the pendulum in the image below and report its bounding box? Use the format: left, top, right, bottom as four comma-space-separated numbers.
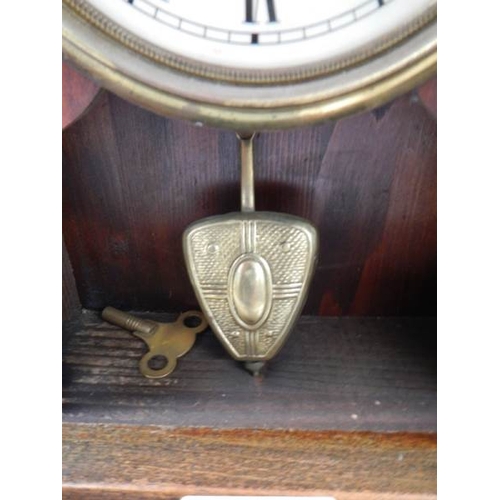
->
63, 85, 436, 315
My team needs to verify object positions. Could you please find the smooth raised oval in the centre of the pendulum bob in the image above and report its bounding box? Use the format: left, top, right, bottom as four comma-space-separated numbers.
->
228, 254, 272, 330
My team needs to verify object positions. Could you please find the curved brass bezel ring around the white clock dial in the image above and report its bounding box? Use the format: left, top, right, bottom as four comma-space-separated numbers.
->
63, 0, 437, 131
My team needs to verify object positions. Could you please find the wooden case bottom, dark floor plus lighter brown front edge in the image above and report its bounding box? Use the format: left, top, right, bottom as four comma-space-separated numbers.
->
63, 312, 436, 500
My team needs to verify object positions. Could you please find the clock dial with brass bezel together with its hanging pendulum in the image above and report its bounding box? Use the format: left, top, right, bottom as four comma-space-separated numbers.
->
63, 0, 437, 372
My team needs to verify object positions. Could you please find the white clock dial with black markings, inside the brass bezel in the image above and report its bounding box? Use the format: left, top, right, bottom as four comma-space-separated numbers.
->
90, 0, 434, 69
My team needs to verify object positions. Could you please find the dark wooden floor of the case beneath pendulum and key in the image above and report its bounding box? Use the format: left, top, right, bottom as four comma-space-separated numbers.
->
63, 312, 436, 432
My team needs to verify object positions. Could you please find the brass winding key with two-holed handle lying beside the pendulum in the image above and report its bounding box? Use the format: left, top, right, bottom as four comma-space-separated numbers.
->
102, 307, 207, 378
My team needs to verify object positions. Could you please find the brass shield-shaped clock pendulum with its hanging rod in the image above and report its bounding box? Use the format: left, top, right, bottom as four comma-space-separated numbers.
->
183, 135, 318, 374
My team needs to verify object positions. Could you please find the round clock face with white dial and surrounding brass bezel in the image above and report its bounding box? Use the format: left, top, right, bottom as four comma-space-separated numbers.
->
63, 0, 436, 130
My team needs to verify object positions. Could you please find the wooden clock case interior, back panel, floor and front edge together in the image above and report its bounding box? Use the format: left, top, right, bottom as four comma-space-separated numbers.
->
63, 66, 436, 500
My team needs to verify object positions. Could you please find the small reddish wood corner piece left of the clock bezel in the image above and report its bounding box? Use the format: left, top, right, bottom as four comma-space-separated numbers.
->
62, 62, 100, 130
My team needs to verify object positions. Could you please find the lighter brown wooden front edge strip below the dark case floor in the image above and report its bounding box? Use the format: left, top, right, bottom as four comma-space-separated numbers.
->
63, 424, 436, 500
